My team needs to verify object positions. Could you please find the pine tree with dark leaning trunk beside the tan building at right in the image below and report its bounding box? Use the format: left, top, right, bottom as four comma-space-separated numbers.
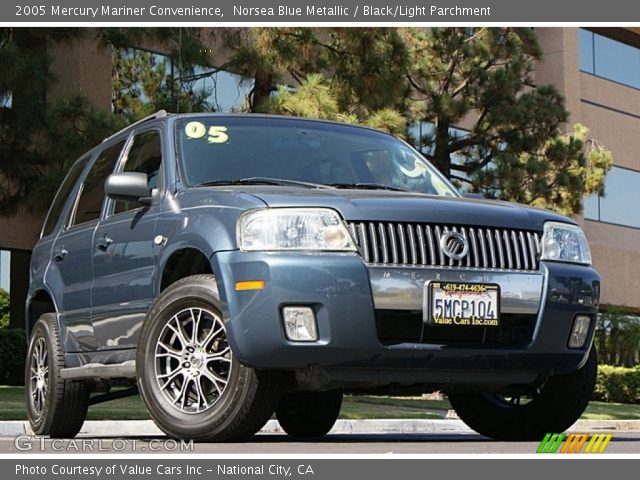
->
403, 27, 612, 215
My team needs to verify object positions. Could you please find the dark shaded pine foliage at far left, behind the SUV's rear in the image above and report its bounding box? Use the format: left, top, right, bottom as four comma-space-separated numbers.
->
0, 27, 115, 214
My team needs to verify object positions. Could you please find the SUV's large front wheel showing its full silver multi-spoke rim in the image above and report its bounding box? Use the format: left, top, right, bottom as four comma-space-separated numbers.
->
136, 275, 280, 442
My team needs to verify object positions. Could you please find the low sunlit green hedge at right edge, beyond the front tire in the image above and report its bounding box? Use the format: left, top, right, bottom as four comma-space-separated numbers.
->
593, 365, 640, 403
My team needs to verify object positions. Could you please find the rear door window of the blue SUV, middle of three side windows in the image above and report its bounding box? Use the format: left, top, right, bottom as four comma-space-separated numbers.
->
71, 140, 125, 225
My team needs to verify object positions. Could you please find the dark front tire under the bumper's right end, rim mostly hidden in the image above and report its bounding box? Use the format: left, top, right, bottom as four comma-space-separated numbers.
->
449, 348, 598, 440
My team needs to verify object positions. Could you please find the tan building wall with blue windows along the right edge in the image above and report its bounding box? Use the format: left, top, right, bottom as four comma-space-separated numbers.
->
536, 28, 640, 313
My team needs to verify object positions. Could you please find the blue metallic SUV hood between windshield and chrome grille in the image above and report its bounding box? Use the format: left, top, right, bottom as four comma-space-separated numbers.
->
216, 185, 575, 231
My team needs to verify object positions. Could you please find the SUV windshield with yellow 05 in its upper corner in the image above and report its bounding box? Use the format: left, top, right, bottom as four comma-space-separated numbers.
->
176, 115, 458, 197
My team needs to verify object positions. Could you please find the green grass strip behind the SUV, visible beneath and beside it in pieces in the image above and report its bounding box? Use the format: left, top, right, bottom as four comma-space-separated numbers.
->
0, 386, 640, 420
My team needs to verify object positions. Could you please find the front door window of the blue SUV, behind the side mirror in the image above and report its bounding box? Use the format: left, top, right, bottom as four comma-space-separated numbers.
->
114, 130, 162, 213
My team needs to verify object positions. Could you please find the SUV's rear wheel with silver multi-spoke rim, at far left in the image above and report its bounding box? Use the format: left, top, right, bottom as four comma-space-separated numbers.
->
25, 313, 90, 438
